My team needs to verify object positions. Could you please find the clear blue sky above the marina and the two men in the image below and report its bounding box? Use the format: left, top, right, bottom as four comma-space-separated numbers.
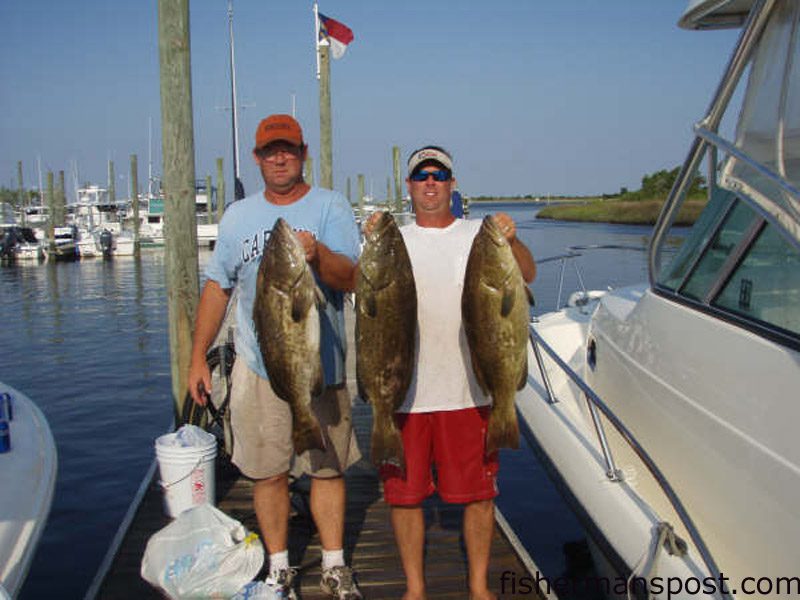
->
0, 0, 737, 196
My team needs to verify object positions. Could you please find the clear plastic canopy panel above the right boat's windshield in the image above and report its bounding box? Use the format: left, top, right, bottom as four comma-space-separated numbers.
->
719, 2, 800, 244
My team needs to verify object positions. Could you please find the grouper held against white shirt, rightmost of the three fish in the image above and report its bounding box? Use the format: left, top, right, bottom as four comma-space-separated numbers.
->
461, 216, 532, 454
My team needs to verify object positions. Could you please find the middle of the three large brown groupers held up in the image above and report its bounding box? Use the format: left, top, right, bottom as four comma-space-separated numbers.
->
356, 212, 417, 470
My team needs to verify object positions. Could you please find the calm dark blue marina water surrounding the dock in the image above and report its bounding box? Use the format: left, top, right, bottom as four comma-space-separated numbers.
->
0, 205, 649, 599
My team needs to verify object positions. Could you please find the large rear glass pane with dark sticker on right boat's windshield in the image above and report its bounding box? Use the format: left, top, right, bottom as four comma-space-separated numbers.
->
713, 225, 800, 333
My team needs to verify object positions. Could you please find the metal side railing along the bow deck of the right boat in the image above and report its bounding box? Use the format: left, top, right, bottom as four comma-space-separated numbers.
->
529, 326, 734, 600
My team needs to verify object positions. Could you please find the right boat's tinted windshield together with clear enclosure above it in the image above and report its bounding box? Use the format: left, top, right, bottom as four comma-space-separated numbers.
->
651, 0, 800, 347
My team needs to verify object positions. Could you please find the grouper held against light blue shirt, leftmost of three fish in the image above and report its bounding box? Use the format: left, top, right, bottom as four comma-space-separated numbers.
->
253, 218, 325, 454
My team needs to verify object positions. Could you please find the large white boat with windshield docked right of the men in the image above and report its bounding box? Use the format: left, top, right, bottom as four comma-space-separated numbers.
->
517, 0, 800, 598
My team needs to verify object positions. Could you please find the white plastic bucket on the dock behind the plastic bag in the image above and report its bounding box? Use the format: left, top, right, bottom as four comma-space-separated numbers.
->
156, 425, 217, 519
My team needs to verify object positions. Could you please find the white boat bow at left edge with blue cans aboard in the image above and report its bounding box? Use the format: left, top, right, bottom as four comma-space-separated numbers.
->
0, 383, 58, 598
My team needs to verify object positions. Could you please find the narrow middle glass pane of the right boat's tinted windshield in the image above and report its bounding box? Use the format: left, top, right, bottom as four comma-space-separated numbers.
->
680, 202, 758, 302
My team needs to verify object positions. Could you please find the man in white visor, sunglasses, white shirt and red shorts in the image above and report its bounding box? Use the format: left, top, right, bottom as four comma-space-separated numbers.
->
376, 146, 536, 600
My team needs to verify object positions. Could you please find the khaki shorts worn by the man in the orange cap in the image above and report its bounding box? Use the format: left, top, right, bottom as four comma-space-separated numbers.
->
231, 360, 361, 479
